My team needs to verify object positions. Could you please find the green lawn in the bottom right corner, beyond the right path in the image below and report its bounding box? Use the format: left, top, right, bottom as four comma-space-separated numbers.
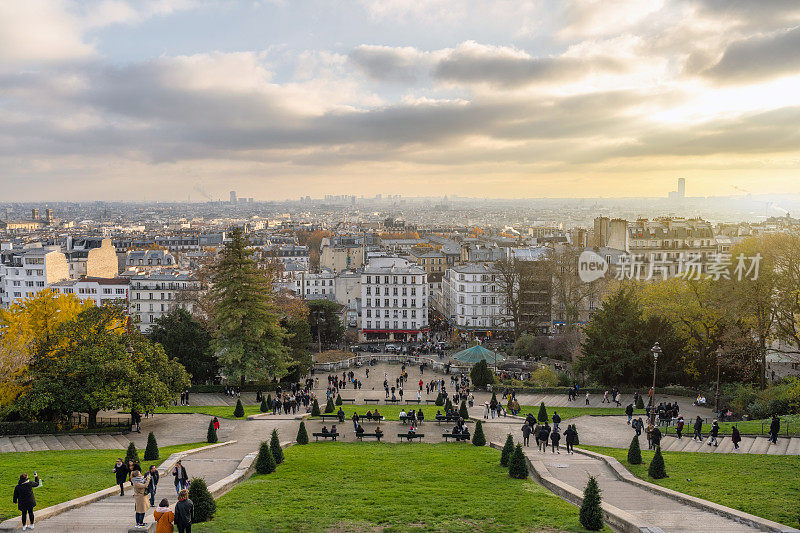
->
581, 446, 800, 527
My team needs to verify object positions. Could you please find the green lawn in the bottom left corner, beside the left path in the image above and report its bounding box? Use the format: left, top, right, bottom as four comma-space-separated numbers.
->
0, 442, 207, 521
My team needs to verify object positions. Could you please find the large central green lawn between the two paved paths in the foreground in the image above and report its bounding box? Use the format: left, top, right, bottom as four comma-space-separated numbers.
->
193, 443, 607, 532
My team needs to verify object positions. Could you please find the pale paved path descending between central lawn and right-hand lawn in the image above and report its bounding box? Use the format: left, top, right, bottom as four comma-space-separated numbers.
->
525, 448, 758, 533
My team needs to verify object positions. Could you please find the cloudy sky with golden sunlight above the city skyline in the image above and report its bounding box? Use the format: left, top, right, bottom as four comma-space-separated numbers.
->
0, 0, 800, 200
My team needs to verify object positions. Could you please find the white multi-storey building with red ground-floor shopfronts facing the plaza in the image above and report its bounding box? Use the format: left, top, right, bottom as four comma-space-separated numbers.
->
361, 257, 429, 341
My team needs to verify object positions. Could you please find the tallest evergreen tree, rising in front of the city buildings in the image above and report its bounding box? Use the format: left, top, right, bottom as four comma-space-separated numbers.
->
209, 227, 287, 384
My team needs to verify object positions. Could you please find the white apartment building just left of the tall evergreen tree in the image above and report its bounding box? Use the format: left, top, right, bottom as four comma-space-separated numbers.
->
129, 271, 200, 331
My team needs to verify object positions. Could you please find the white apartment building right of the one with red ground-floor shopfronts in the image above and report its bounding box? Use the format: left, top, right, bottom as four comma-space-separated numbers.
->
437, 263, 510, 332
